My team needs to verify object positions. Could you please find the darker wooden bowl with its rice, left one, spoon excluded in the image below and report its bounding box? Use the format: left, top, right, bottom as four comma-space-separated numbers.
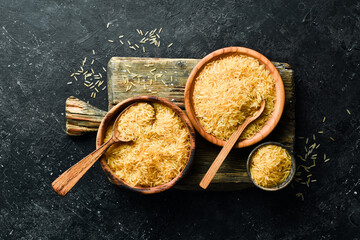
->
96, 96, 195, 194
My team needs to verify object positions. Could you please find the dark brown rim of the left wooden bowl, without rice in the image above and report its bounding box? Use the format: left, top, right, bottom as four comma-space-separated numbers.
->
96, 96, 195, 194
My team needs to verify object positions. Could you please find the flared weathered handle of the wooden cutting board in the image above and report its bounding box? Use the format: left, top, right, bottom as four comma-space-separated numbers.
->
65, 96, 106, 136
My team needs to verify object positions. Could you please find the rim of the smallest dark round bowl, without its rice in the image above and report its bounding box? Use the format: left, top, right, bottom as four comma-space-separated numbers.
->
246, 142, 296, 191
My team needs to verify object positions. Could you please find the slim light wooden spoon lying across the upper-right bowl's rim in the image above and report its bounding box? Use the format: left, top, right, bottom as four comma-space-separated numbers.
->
200, 100, 265, 189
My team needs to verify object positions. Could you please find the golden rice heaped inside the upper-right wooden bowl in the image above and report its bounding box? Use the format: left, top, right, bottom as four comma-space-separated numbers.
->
193, 54, 276, 141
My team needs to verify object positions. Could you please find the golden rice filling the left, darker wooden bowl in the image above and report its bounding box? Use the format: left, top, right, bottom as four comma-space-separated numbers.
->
105, 103, 190, 187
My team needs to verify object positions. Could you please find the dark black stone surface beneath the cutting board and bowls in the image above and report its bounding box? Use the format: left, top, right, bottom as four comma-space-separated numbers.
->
0, 0, 360, 239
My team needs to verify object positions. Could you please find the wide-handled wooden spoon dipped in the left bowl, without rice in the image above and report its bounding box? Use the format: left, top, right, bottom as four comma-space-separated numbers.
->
51, 103, 155, 196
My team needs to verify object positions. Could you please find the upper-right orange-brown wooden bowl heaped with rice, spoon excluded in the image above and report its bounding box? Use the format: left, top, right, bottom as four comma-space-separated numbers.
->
185, 47, 285, 148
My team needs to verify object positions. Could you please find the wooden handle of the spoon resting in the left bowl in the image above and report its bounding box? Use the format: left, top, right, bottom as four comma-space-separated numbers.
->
51, 138, 115, 196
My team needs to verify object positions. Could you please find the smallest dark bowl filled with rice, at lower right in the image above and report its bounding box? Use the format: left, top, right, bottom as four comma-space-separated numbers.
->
246, 142, 296, 191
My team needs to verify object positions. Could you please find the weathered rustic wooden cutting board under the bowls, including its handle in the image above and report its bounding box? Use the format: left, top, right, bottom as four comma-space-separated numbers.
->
66, 57, 295, 190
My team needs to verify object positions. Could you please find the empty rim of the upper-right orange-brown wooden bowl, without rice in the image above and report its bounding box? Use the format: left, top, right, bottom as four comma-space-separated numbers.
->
185, 47, 285, 148
